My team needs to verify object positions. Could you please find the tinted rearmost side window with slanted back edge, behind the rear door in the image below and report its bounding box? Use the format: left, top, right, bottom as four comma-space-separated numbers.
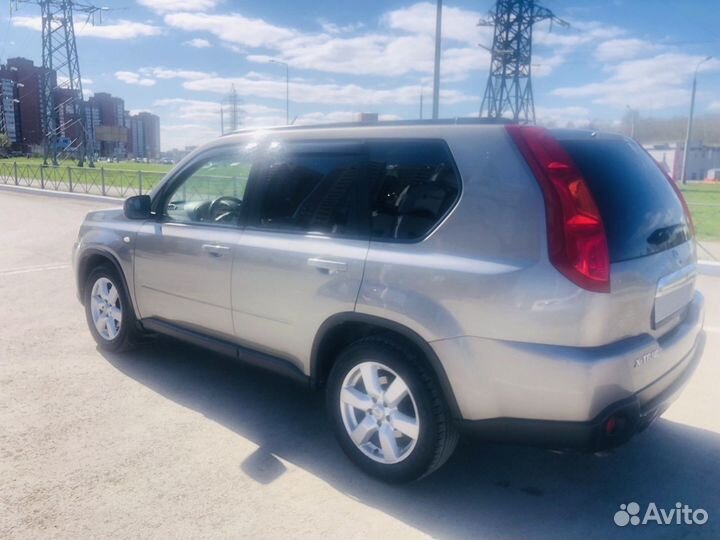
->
368, 140, 460, 241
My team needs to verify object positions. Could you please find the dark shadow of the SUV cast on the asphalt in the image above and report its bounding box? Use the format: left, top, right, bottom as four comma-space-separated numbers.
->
103, 340, 720, 538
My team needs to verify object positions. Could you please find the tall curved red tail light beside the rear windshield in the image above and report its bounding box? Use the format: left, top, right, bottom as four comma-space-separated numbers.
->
506, 125, 610, 292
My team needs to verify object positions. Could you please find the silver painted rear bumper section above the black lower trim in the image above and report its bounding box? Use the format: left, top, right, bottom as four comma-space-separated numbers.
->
430, 292, 704, 423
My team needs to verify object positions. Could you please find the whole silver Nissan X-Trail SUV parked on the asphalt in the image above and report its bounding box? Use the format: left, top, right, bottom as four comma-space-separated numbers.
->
74, 122, 705, 482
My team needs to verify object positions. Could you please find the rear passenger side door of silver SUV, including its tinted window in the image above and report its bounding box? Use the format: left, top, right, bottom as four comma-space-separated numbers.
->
232, 141, 369, 373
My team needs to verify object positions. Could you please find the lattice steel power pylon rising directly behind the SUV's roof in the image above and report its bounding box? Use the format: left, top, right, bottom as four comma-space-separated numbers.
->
478, 0, 569, 124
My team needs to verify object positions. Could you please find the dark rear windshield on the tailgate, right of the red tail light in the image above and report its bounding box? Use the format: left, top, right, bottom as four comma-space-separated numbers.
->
560, 139, 690, 262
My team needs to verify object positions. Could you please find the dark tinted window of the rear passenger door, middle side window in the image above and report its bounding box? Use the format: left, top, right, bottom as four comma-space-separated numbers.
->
257, 149, 364, 236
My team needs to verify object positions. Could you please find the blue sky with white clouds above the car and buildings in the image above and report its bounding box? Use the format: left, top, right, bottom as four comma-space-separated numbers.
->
0, 0, 720, 150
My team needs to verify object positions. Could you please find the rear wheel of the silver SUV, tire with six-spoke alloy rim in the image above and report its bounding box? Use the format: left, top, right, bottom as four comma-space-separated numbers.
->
327, 336, 458, 483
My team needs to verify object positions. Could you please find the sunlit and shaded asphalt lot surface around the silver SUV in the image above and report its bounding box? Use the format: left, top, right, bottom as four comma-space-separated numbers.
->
0, 187, 720, 540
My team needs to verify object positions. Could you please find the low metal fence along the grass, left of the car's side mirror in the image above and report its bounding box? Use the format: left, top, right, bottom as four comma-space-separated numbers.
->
0, 162, 165, 198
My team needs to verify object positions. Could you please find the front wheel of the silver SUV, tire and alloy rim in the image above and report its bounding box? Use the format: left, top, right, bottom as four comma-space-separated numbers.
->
83, 265, 141, 353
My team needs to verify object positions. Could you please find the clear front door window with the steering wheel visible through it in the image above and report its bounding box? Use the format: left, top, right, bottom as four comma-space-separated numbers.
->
163, 148, 254, 225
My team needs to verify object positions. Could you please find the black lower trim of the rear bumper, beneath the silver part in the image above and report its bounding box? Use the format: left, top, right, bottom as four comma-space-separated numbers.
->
460, 332, 705, 451
